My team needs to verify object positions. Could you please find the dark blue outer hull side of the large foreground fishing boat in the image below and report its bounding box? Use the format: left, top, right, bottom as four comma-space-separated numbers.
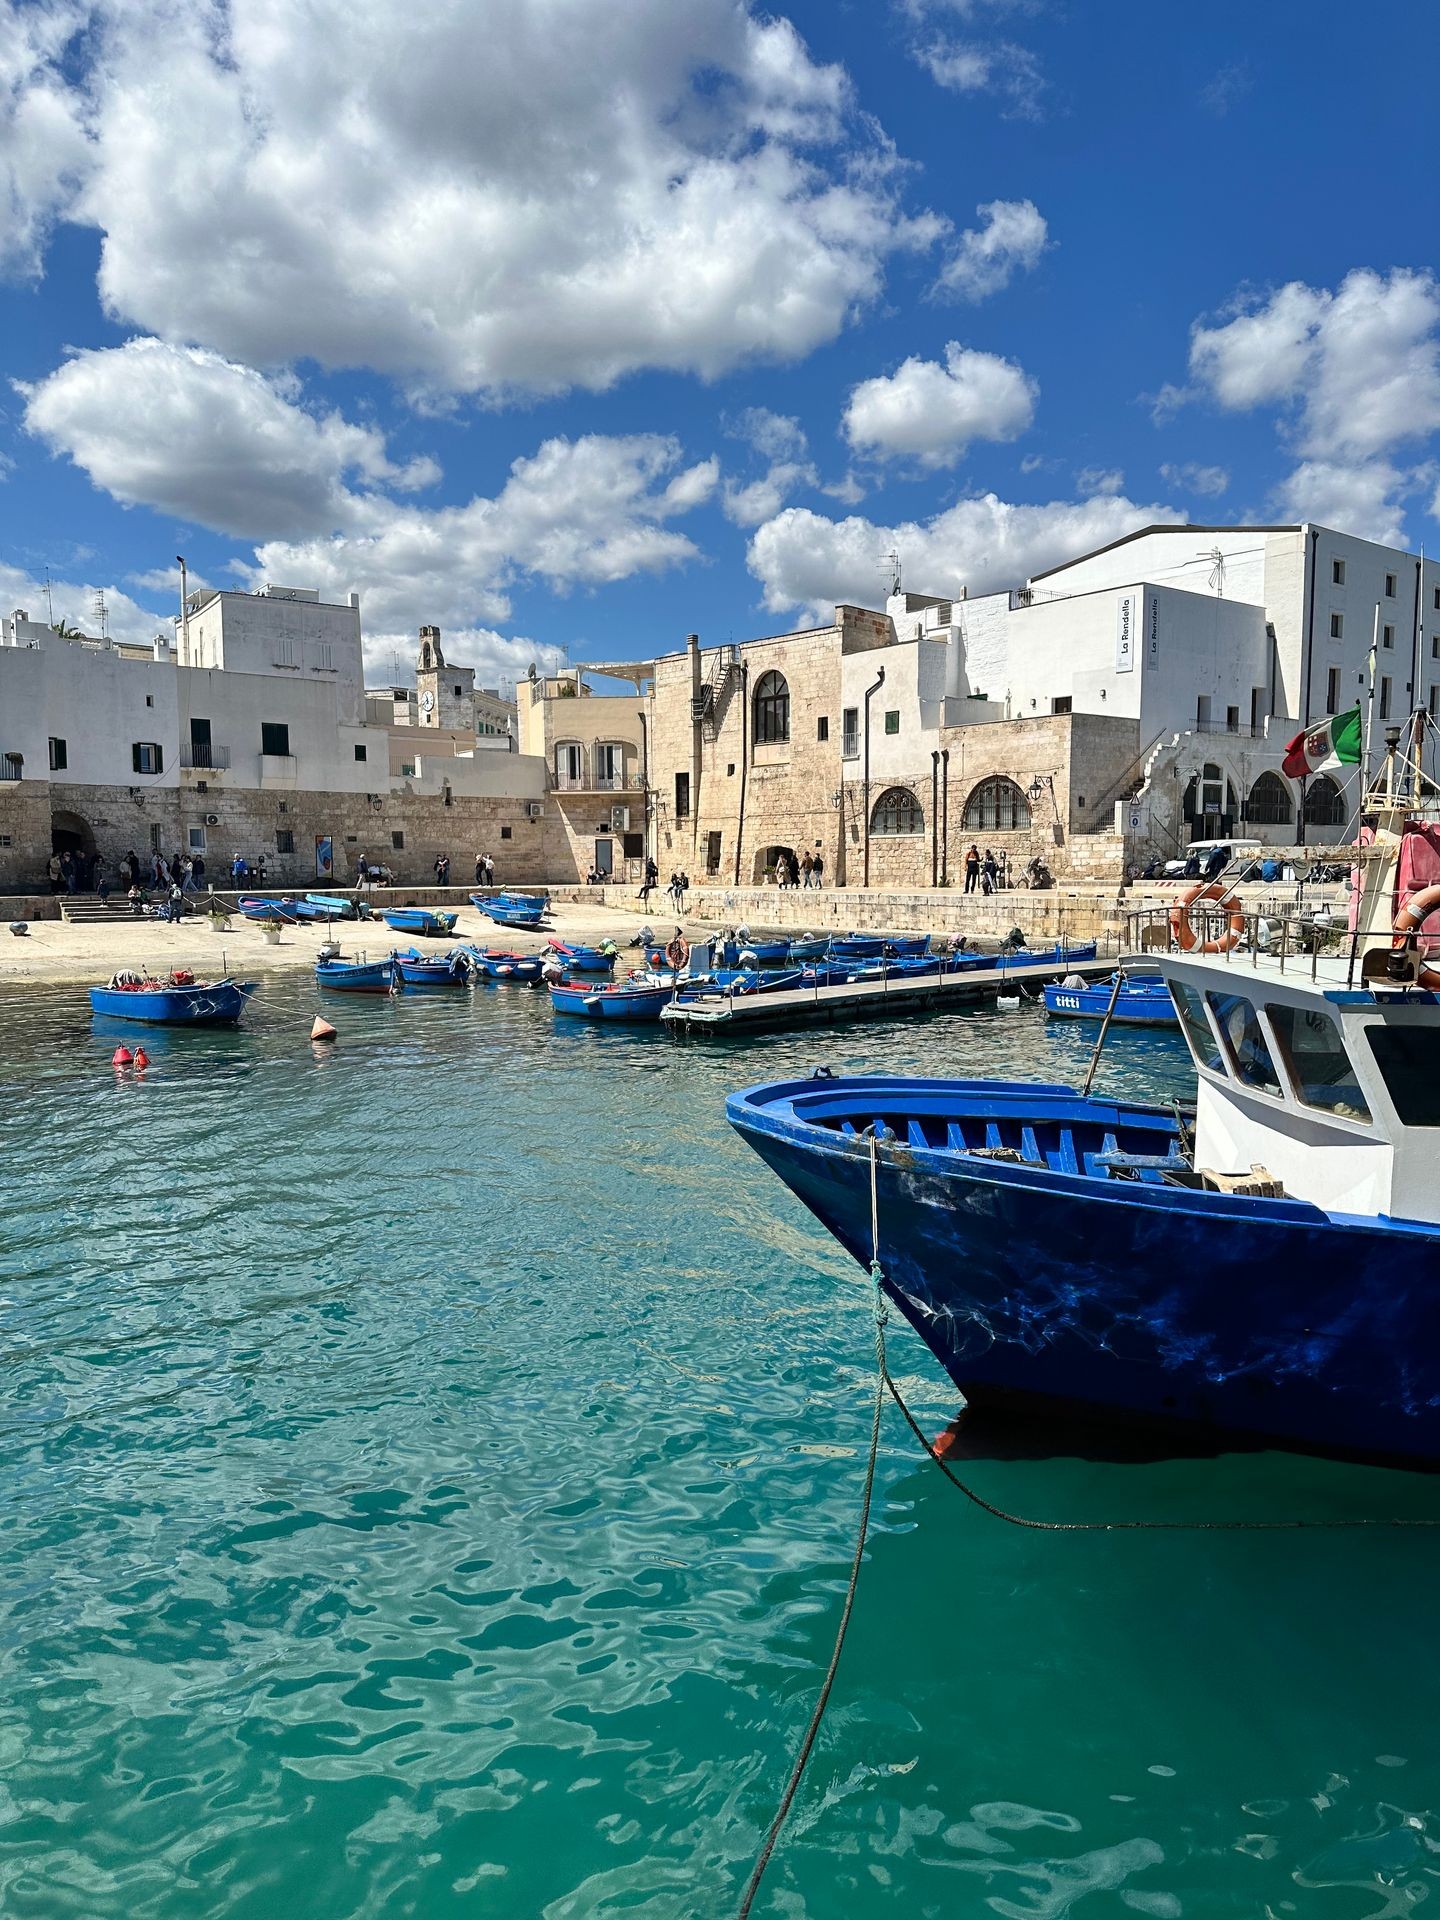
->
730, 1083, 1440, 1463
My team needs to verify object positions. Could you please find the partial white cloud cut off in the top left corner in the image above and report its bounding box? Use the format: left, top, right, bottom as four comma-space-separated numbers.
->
0, 0, 88, 278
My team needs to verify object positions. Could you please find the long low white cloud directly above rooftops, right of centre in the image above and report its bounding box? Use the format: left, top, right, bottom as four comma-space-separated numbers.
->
747, 493, 1185, 618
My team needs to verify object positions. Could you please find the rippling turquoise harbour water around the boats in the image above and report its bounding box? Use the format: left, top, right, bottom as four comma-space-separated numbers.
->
0, 981, 1440, 1920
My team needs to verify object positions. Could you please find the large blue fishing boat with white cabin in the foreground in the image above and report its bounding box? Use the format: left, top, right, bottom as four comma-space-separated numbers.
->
728, 771, 1440, 1463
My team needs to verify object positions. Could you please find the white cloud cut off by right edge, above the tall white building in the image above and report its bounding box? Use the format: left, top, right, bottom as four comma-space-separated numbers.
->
1190, 267, 1440, 543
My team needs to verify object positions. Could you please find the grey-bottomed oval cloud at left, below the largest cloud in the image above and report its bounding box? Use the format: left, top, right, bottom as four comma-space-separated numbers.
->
19, 340, 440, 540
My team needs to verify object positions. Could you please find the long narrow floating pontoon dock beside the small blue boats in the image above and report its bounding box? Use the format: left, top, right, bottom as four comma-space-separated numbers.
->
660, 956, 1116, 1033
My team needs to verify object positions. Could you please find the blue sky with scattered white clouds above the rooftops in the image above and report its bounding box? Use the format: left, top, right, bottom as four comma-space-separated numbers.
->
0, 0, 1440, 685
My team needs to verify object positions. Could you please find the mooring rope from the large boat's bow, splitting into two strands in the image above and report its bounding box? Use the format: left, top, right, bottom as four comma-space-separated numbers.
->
735, 1131, 1440, 1920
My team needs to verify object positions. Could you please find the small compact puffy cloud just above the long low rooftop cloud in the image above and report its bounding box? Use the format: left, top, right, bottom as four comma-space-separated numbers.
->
843, 340, 1039, 467
